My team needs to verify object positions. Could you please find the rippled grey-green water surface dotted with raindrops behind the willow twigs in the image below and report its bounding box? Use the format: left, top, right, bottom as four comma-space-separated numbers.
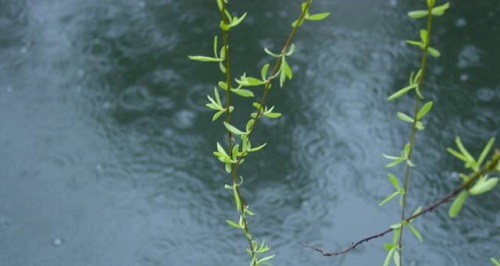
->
0, 0, 500, 266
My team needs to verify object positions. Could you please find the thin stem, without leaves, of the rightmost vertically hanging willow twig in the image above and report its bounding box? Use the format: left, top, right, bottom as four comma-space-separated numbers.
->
398, 7, 432, 265
